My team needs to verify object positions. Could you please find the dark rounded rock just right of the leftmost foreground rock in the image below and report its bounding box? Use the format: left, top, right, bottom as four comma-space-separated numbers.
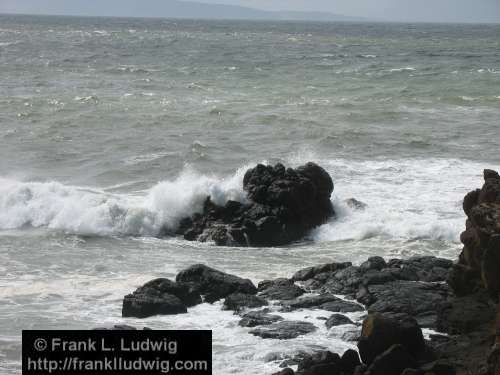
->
176, 264, 257, 303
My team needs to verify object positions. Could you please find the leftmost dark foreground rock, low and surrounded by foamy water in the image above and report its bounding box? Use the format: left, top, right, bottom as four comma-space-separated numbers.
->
122, 278, 201, 318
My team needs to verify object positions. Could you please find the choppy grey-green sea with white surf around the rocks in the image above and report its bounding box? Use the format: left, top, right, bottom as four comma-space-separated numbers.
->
0, 16, 500, 374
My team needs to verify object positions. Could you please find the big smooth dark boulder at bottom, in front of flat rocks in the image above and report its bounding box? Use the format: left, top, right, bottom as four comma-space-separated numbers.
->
358, 314, 426, 368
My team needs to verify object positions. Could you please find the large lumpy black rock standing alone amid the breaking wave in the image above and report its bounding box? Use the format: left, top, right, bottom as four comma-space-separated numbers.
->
177, 163, 334, 246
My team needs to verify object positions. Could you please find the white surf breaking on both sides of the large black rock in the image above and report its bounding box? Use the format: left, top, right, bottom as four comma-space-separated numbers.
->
0, 158, 487, 242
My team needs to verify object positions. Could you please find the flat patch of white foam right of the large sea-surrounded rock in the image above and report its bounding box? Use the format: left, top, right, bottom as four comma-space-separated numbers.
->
314, 159, 485, 242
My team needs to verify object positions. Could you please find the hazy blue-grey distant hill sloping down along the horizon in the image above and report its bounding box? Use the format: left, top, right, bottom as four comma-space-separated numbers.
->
0, 0, 363, 21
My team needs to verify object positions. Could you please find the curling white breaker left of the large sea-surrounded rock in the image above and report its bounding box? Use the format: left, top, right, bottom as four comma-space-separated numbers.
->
0, 169, 248, 236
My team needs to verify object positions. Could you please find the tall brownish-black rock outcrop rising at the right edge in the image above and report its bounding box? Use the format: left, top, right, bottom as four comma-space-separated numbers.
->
448, 169, 500, 296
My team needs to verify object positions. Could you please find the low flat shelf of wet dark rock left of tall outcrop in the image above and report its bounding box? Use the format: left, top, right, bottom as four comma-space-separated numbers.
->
290, 256, 453, 327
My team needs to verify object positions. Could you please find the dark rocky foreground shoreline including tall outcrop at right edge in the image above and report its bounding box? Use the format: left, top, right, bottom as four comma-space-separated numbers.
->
118, 164, 500, 375
